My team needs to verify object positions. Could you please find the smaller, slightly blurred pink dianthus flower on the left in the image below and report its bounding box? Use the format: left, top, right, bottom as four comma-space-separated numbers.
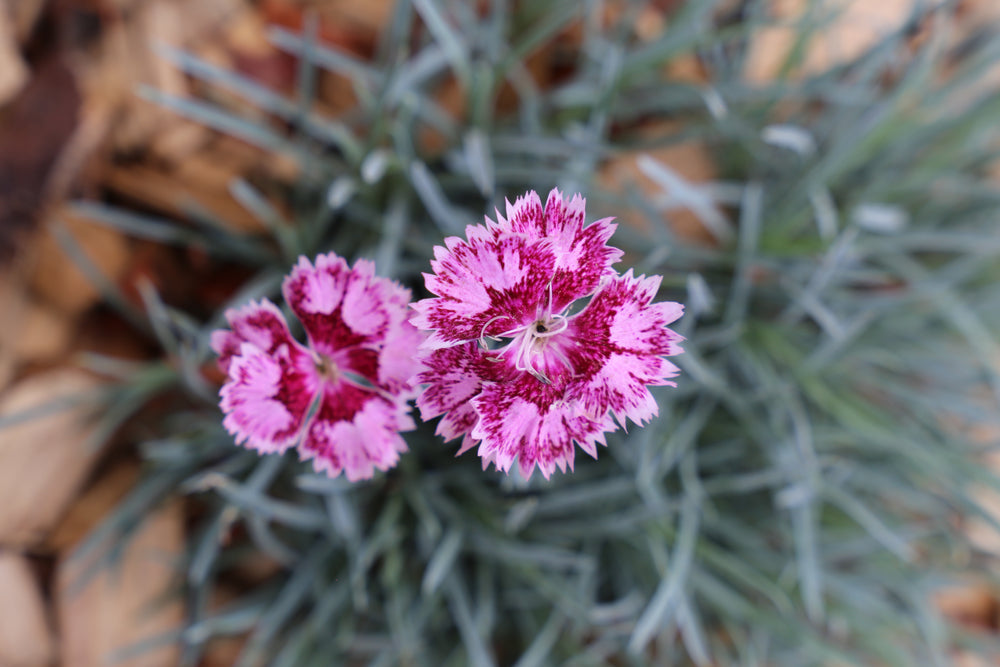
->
212, 253, 421, 481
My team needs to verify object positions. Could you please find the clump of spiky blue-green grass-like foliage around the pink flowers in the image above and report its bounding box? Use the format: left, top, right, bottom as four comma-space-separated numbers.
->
74, 0, 1000, 665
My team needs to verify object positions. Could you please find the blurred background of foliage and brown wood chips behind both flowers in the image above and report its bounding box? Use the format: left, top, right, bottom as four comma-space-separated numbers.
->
0, 0, 1000, 667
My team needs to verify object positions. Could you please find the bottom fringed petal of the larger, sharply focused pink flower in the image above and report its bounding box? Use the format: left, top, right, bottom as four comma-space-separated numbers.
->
471, 375, 617, 479
